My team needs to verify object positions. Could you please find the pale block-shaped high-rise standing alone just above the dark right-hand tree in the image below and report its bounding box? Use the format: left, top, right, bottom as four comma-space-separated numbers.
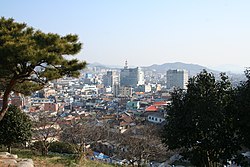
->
166, 69, 188, 89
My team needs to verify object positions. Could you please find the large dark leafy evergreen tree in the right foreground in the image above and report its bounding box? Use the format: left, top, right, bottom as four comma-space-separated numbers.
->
162, 70, 243, 167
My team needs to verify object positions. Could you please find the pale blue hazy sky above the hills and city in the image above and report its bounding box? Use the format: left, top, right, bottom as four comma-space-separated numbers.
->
0, 0, 250, 71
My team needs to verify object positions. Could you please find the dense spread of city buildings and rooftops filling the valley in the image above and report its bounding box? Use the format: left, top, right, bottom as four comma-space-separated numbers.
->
0, 62, 193, 166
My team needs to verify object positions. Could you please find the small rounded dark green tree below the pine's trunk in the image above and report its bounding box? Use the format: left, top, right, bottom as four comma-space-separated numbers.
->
0, 105, 32, 152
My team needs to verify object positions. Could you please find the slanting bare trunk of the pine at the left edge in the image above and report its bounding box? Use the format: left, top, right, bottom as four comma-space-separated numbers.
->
0, 79, 16, 121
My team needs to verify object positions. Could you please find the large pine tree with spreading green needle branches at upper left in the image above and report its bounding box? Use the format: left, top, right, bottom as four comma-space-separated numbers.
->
0, 17, 86, 121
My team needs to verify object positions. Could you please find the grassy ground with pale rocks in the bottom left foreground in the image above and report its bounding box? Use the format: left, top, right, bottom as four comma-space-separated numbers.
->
0, 148, 115, 167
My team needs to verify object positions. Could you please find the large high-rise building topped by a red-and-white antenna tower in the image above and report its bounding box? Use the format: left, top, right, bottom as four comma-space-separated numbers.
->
120, 61, 144, 88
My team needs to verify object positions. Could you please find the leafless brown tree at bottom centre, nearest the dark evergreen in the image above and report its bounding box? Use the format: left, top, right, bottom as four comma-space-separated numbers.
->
117, 125, 167, 166
